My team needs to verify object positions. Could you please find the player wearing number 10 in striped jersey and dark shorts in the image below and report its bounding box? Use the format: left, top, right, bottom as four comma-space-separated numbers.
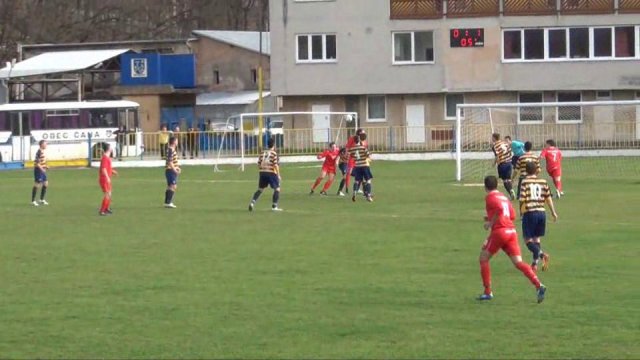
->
519, 161, 558, 271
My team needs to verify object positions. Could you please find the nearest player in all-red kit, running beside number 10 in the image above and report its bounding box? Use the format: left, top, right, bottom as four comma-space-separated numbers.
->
477, 176, 547, 303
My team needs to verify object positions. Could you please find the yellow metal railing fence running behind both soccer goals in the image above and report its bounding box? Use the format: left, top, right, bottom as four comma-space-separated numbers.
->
100, 121, 640, 159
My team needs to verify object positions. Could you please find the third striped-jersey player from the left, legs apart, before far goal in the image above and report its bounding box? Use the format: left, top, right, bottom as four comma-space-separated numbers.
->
249, 139, 282, 211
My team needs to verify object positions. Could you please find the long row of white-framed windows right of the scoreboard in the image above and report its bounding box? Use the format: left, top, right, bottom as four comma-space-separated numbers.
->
502, 25, 640, 62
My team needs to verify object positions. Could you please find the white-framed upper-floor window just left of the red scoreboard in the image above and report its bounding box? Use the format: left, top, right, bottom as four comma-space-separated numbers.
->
393, 31, 434, 64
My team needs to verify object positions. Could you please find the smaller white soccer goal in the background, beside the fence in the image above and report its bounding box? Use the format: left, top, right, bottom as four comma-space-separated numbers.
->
214, 112, 358, 171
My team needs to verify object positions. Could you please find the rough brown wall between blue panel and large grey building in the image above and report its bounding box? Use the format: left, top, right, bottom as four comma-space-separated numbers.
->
193, 37, 271, 91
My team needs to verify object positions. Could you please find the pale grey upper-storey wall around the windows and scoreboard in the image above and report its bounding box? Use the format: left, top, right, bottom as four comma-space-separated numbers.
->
270, 0, 640, 95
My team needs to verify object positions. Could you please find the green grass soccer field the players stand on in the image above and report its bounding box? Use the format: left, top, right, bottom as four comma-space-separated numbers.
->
0, 160, 640, 359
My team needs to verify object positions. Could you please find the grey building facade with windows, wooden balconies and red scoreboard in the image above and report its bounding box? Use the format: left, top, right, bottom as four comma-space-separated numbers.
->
270, 0, 640, 145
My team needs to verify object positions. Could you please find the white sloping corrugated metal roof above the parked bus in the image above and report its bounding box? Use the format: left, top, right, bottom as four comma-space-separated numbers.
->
0, 49, 129, 79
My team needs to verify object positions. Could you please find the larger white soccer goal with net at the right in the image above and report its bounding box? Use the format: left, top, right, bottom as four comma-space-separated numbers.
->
455, 100, 640, 184
